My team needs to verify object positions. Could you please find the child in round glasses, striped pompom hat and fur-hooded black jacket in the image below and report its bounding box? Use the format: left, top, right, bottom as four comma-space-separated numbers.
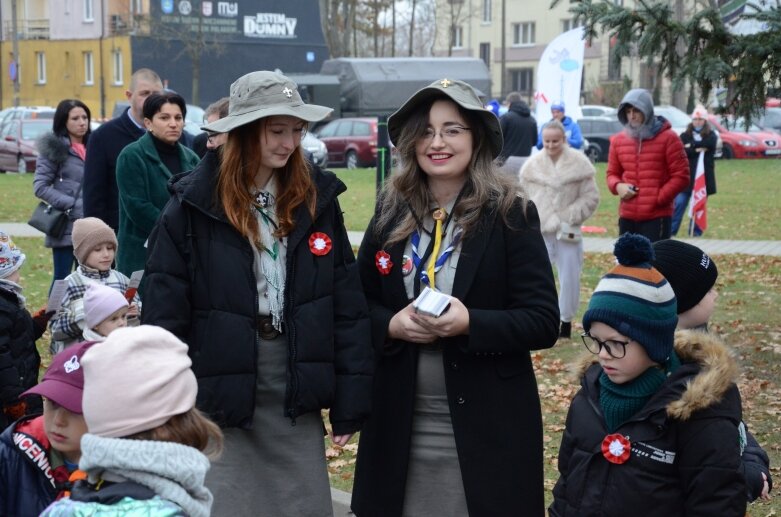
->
550, 234, 746, 517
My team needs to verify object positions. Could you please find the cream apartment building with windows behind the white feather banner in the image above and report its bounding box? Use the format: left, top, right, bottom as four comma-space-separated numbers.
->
434, 0, 680, 105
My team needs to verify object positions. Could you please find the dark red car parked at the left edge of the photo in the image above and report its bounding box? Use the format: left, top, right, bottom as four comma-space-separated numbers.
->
0, 118, 52, 174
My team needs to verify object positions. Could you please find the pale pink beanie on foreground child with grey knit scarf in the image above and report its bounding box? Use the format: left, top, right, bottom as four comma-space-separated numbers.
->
81, 325, 198, 438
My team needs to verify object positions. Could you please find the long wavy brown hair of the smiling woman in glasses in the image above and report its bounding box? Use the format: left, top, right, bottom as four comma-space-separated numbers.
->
375, 95, 526, 246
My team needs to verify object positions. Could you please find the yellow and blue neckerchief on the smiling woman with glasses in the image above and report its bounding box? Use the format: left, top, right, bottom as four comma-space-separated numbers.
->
411, 188, 464, 296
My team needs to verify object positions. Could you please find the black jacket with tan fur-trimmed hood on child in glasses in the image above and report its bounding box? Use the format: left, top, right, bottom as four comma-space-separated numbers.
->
549, 331, 746, 517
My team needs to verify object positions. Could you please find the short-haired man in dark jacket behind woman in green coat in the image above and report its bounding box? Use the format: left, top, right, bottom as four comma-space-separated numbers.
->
82, 68, 163, 231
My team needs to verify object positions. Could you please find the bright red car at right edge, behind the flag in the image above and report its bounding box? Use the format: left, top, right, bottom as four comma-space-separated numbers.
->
708, 115, 781, 159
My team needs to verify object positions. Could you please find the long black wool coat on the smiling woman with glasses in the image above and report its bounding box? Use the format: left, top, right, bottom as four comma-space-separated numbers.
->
352, 196, 559, 517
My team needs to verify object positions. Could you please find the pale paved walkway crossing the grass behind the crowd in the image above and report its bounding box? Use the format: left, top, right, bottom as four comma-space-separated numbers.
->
0, 222, 781, 257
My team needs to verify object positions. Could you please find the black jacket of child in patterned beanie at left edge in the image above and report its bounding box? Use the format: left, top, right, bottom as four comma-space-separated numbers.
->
0, 286, 43, 429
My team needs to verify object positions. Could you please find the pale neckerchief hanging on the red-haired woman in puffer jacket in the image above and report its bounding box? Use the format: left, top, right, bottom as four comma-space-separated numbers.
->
252, 183, 285, 332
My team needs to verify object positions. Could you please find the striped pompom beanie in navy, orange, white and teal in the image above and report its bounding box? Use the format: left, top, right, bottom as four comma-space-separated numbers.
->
583, 233, 678, 364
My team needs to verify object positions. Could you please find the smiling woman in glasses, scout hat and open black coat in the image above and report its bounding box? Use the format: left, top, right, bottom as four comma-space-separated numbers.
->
352, 79, 559, 517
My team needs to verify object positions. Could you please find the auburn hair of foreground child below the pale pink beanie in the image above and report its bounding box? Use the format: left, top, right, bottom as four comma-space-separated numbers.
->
126, 408, 224, 459
